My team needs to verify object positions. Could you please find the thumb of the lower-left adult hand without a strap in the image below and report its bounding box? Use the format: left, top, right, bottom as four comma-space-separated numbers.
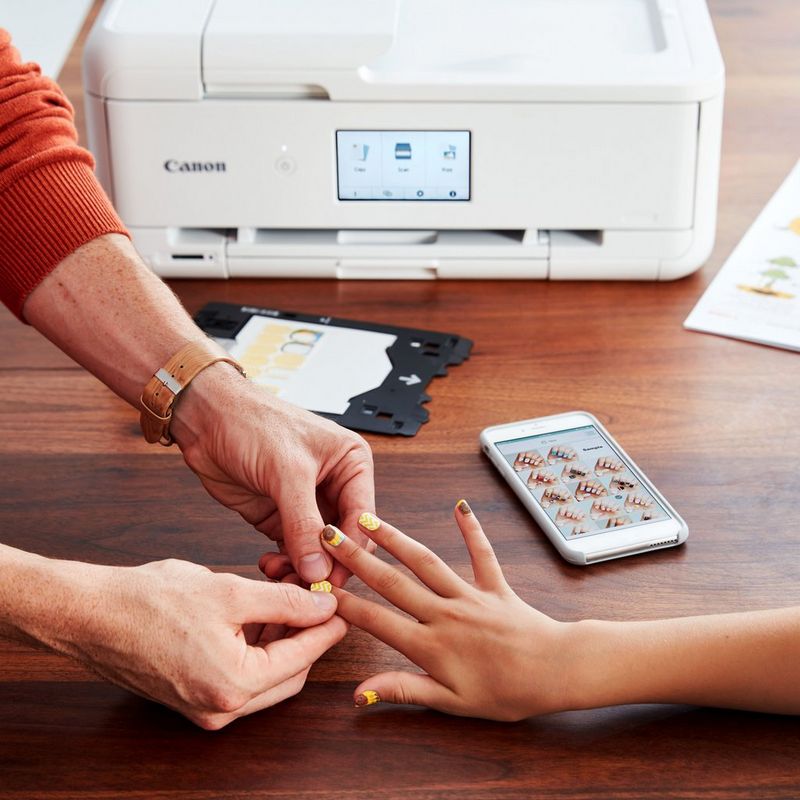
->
234, 578, 336, 628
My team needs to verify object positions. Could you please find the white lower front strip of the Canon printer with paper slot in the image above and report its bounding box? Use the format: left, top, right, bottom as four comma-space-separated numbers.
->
131, 227, 693, 280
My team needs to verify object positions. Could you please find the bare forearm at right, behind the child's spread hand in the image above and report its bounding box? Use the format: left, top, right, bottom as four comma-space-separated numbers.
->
573, 608, 800, 714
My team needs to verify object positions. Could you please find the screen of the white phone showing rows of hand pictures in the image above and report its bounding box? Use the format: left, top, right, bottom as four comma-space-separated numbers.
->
495, 425, 669, 539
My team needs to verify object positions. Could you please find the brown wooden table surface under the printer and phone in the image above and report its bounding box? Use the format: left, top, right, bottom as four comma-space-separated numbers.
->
0, 0, 800, 800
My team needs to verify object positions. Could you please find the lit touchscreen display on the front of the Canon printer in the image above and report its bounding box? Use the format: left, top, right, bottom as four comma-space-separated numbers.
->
336, 131, 470, 201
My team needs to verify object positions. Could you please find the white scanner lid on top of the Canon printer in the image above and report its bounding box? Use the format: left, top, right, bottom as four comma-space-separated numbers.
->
85, 0, 724, 102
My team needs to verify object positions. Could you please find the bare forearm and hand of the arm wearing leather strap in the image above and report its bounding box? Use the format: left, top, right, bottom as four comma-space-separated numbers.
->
24, 235, 374, 583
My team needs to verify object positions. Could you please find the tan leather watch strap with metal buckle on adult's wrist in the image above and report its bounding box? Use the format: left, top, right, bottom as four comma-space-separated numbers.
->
139, 340, 245, 447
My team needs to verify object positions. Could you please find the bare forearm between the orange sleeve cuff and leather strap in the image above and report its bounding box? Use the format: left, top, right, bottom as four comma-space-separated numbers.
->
23, 234, 209, 405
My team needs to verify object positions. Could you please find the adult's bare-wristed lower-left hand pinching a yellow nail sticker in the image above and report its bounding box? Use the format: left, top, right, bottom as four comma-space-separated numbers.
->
39, 560, 347, 730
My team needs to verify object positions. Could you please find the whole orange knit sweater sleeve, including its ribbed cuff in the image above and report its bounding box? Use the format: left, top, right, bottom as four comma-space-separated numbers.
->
0, 29, 127, 317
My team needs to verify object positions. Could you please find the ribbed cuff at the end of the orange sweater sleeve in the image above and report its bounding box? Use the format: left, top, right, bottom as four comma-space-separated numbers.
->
0, 161, 128, 321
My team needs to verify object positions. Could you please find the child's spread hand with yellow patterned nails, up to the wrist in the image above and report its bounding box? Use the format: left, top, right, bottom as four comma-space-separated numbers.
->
322, 500, 572, 720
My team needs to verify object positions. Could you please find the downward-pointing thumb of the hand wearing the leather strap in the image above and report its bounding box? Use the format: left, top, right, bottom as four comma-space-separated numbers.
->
278, 482, 333, 583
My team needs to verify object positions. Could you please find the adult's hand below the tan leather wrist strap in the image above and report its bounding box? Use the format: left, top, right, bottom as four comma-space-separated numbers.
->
171, 363, 375, 585
